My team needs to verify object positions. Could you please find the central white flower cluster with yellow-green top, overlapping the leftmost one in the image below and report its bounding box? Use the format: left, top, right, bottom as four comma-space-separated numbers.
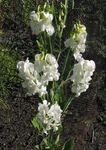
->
34, 54, 60, 82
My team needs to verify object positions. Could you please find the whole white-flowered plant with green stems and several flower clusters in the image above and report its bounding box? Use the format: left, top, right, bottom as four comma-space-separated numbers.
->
17, 0, 95, 150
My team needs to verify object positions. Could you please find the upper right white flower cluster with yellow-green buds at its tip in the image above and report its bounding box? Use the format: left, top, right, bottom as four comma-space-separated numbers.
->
65, 23, 87, 61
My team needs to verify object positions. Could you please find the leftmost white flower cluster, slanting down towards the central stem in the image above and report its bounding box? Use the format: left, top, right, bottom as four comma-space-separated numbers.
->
17, 56, 47, 96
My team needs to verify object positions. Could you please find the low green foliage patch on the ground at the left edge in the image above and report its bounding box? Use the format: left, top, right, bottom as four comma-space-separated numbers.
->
0, 47, 20, 97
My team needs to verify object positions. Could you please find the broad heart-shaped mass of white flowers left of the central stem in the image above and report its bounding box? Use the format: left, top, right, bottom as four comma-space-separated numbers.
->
17, 54, 60, 96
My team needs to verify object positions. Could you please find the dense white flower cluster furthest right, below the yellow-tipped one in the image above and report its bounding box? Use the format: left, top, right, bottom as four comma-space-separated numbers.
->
71, 59, 95, 96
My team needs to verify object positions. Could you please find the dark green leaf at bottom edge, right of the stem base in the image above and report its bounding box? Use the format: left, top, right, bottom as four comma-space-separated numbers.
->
62, 139, 74, 150
